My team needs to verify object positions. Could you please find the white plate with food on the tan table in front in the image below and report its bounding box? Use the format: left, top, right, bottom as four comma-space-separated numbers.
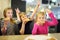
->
24, 35, 57, 40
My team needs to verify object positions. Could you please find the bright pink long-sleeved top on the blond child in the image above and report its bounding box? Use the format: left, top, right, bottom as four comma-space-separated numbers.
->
32, 13, 58, 35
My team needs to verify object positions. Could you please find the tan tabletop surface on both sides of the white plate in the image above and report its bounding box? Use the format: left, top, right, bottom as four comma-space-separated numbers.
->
0, 33, 60, 40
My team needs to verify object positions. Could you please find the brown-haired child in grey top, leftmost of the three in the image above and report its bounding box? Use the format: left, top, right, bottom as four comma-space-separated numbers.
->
1, 8, 18, 35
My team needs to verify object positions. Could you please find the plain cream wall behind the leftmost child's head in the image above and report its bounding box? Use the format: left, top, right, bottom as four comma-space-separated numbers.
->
0, 0, 11, 18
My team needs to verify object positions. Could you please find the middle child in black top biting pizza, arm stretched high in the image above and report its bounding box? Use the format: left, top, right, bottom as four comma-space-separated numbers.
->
18, 2, 40, 34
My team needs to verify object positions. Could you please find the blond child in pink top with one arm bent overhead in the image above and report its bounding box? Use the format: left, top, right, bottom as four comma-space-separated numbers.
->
32, 9, 58, 35
